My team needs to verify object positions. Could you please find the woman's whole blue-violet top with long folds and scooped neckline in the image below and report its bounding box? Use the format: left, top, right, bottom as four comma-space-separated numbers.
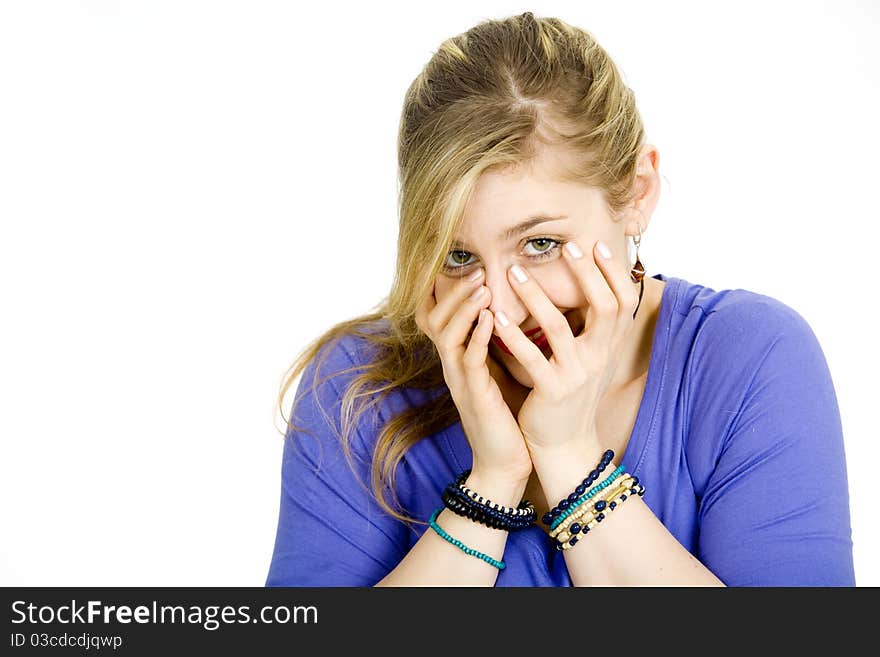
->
266, 274, 855, 586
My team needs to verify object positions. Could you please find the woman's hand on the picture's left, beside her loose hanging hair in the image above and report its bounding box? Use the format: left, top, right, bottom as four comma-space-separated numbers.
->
415, 268, 532, 483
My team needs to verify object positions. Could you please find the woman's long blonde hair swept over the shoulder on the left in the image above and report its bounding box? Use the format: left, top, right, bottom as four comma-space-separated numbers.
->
278, 12, 644, 526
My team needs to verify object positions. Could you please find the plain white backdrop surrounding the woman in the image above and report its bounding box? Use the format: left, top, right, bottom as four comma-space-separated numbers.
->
0, 0, 880, 586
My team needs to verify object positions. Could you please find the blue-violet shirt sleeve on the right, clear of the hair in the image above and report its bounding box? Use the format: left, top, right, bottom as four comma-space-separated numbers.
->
694, 297, 855, 586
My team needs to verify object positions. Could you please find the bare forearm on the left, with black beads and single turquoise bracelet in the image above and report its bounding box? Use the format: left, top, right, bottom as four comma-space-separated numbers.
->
376, 473, 526, 586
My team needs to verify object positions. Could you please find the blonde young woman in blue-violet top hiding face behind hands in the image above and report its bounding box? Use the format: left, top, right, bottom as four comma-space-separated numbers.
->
266, 13, 854, 586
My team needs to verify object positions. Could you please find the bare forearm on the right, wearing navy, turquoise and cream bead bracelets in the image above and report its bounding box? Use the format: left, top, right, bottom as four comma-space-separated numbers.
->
532, 439, 724, 586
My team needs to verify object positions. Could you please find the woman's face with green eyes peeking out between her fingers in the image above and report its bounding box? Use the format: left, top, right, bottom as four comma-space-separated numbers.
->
434, 149, 627, 388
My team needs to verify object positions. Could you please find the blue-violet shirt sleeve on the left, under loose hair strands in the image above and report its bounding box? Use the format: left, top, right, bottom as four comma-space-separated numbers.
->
266, 341, 408, 586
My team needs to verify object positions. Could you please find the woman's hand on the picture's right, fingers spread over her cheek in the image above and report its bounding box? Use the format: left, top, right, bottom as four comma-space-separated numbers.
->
495, 242, 639, 449
